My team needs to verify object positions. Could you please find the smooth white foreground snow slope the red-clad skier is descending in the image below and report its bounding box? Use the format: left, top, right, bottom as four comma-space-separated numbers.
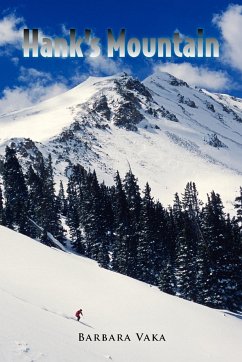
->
0, 226, 242, 362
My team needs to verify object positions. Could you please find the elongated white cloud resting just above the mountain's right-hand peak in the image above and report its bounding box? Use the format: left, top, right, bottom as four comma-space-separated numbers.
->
154, 63, 232, 91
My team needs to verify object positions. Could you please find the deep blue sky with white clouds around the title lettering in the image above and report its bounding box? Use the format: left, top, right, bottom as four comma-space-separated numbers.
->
0, 0, 242, 113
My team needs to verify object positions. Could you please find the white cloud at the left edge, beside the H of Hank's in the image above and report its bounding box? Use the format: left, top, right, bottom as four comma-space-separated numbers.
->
0, 15, 25, 47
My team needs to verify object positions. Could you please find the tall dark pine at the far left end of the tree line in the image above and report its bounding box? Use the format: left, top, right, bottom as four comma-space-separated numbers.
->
3, 147, 30, 235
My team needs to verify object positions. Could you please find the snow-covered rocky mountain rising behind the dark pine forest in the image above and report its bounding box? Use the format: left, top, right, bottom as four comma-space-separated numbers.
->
0, 73, 242, 210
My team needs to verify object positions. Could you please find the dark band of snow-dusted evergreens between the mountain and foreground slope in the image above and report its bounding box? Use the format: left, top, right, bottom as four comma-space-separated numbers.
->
0, 147, 242, 311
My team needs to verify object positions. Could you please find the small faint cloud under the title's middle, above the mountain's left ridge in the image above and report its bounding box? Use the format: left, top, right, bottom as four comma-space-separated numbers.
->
85, 55, 130, 75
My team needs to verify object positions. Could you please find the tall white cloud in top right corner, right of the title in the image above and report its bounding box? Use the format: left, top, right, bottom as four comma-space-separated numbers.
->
213, 5, 242, 71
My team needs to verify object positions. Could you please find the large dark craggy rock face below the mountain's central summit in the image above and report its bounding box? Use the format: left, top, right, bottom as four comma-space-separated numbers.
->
68, 73, 178, 131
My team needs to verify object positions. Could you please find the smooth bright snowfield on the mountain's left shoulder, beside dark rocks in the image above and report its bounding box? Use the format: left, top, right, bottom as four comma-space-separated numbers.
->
0, 77, 111, 142
